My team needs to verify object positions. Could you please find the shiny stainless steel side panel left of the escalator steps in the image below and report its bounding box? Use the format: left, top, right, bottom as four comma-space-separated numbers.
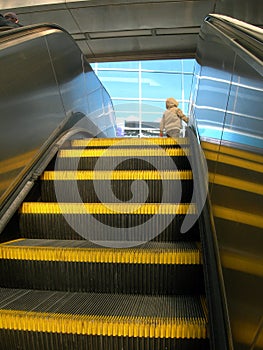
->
0, 28, 115, 211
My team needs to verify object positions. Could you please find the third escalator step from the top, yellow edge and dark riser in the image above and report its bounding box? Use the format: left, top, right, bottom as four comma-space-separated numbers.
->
41, 170, 193, 203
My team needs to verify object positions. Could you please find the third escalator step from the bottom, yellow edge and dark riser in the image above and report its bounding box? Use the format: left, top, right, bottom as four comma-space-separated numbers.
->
20, 202, 199, 242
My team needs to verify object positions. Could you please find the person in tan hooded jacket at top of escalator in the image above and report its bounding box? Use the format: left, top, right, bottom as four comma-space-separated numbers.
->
160, 97, 188, 138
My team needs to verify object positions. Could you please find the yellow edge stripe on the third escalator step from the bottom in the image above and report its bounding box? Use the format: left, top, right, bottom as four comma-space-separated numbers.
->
20, 202, 197, 215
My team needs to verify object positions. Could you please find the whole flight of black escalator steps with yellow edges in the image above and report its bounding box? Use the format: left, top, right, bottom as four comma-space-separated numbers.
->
0, 138, 211, 350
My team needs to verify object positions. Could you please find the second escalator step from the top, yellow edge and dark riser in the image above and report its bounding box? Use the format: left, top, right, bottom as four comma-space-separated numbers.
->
56, 147, 191, 170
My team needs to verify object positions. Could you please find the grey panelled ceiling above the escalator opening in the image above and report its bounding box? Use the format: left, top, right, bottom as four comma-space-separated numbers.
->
0, 0, 263, 62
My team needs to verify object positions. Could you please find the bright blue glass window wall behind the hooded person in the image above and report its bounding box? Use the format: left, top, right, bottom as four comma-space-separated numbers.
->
92, 59, 196, 136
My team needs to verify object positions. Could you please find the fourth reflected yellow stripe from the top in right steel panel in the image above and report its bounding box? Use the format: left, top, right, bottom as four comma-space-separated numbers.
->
213, 205, 263, 228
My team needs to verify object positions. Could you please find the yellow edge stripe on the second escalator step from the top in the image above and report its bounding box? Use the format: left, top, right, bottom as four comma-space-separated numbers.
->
59, 148, 189, 158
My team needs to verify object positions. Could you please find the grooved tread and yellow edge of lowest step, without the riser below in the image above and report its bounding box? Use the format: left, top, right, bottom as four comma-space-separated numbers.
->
0, 289, 207, 339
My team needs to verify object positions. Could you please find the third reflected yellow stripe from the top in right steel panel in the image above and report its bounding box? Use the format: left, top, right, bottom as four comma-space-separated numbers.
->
209, 173, 263, 195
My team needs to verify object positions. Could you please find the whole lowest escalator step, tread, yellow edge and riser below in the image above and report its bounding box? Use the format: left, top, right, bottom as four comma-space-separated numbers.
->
0, 289, 208, 350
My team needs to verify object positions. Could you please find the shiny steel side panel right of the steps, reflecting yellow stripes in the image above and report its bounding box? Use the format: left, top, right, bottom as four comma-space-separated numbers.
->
192, 14, 263, 350
